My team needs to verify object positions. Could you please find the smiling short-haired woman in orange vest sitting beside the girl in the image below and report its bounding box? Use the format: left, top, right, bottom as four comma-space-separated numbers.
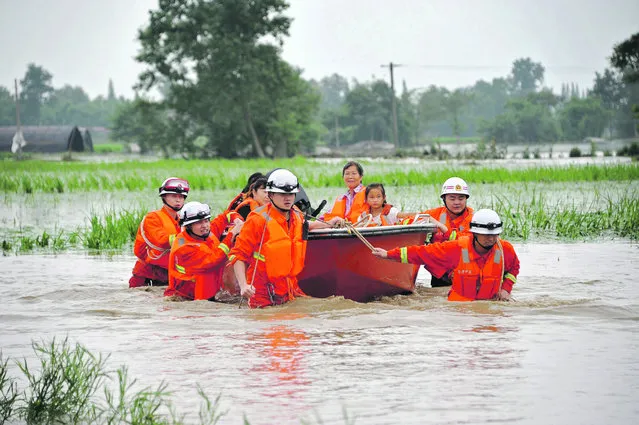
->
323, 161, 366, 223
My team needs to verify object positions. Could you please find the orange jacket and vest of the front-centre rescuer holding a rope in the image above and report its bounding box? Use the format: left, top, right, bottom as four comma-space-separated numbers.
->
231, 204, 306, 307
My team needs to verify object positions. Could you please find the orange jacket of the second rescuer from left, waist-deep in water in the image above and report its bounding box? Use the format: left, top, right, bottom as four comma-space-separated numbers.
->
164, 230, 233, 300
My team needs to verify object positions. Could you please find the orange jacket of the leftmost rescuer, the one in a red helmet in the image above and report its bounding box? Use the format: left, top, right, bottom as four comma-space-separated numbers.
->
133, 207, 180, 269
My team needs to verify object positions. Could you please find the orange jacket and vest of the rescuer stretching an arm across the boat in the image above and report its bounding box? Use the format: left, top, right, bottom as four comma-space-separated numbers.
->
388, 236, 519, 301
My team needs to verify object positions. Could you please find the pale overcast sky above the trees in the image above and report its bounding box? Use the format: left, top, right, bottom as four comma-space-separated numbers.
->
0, 0, 639, 97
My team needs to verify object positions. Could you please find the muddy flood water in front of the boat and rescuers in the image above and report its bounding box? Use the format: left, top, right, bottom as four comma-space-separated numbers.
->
0, 240, 639, 424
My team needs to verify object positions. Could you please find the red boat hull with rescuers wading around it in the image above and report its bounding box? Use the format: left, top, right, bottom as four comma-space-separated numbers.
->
299, 223, 435, 302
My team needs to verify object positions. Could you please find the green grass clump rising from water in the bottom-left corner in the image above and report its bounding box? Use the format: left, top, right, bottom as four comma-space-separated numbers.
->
0, 338, 354, 425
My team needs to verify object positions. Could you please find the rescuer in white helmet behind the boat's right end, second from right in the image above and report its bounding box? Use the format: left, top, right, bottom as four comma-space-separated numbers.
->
423, 177, 474, 288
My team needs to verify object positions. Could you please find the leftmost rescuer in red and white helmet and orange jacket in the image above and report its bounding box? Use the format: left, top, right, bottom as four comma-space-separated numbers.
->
129, 177, 189, 288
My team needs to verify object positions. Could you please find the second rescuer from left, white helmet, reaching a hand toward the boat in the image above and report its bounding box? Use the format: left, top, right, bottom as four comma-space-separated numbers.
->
164, 202, 243, 300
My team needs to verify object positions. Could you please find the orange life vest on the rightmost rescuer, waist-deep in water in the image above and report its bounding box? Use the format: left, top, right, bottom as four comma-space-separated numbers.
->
448, 237, 505, 301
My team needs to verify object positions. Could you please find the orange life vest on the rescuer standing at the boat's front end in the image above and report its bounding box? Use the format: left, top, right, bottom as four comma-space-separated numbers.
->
246, 204, 306, 306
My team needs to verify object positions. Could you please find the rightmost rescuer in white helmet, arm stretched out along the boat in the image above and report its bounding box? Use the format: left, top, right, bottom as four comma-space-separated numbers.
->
373, 209, 519, 301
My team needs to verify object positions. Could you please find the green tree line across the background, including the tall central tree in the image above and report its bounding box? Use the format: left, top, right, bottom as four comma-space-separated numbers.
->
0, 0, 639, 158
